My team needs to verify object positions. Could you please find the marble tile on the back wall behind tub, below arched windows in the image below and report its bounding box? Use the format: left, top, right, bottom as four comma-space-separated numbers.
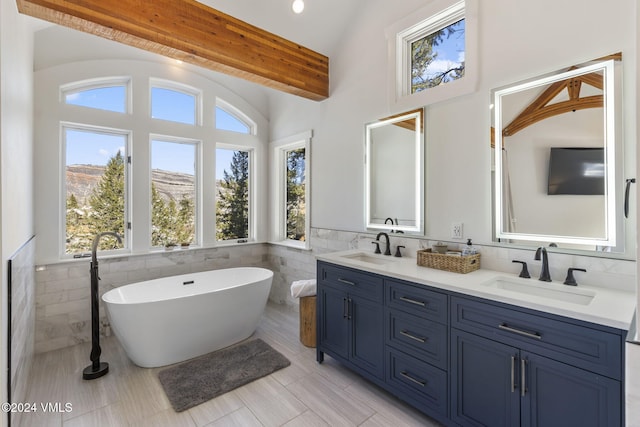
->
35, 244, 269, 353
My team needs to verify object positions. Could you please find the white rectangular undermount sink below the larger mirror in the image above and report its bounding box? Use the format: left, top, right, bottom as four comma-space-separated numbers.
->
482, 277, 596, 305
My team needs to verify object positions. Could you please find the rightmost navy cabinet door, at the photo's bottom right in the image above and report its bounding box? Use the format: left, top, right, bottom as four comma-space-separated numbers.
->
521, 351, 624, 427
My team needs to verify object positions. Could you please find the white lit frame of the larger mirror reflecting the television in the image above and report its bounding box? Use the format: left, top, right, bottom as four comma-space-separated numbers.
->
493, 59, 617, 247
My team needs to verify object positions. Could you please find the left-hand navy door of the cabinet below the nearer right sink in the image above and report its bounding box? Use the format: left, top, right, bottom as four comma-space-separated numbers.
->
451, 329, 520, 427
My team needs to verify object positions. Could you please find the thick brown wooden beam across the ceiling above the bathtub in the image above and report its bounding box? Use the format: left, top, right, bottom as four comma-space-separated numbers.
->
16, 0, 329, 101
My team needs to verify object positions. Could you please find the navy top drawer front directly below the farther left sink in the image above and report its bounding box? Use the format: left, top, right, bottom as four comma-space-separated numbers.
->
318, 263, 383, 302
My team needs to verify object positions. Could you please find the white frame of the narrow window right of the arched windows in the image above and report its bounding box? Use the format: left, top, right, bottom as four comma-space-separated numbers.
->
270, 130, 313, 250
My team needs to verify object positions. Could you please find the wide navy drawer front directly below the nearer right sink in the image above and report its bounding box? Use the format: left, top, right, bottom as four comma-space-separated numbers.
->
451, 297, 624, 380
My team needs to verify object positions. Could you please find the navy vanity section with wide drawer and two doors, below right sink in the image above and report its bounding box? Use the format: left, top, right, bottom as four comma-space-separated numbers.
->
451, 297, 624, 427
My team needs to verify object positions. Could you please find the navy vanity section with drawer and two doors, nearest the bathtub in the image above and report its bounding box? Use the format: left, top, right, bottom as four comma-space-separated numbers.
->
316, 263, 384, 380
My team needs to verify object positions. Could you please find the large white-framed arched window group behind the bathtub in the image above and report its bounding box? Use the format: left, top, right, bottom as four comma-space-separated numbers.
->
35, 61, 268, 259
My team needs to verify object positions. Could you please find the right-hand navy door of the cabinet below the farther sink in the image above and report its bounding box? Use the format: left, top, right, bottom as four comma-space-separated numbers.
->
349, 295, 384, 378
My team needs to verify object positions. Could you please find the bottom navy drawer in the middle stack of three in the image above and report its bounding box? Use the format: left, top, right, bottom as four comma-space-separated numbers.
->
387, 349, 449, 415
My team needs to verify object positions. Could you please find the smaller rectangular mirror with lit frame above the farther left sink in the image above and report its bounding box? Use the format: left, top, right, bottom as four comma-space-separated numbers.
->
365, 109, 424, 235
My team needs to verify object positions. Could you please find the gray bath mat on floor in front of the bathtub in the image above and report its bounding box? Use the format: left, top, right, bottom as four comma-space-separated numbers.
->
158, 338, 291, 412
